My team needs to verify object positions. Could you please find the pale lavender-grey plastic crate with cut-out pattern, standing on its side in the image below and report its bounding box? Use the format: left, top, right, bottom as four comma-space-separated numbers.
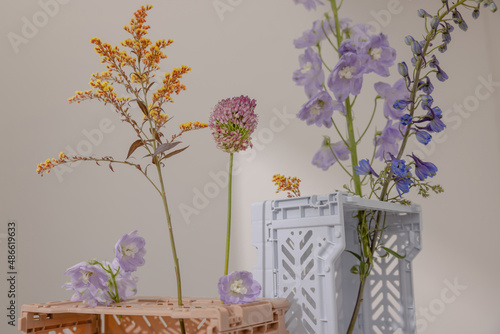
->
252, 192, 422, 334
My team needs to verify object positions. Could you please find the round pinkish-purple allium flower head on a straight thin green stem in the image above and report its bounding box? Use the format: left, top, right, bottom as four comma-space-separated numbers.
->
208, 95, 258, 275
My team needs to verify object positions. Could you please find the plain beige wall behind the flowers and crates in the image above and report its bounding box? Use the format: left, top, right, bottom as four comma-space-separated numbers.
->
0, 0, 500, 334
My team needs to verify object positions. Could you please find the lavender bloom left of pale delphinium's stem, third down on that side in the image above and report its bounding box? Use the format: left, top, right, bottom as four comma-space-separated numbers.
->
297, 91, 345, 128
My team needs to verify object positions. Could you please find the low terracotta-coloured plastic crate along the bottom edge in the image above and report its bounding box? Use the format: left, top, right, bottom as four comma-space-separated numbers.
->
19, 297, 289, 334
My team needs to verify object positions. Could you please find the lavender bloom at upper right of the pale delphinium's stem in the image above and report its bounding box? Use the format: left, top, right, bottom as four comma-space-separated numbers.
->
362, 34, 396, 77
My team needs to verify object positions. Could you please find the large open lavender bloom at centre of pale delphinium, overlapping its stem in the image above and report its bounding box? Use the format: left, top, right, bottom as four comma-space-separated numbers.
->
327, 52, 370, 102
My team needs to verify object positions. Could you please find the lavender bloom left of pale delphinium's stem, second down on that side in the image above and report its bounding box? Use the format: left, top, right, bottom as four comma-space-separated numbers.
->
293, 48, 325, 98
